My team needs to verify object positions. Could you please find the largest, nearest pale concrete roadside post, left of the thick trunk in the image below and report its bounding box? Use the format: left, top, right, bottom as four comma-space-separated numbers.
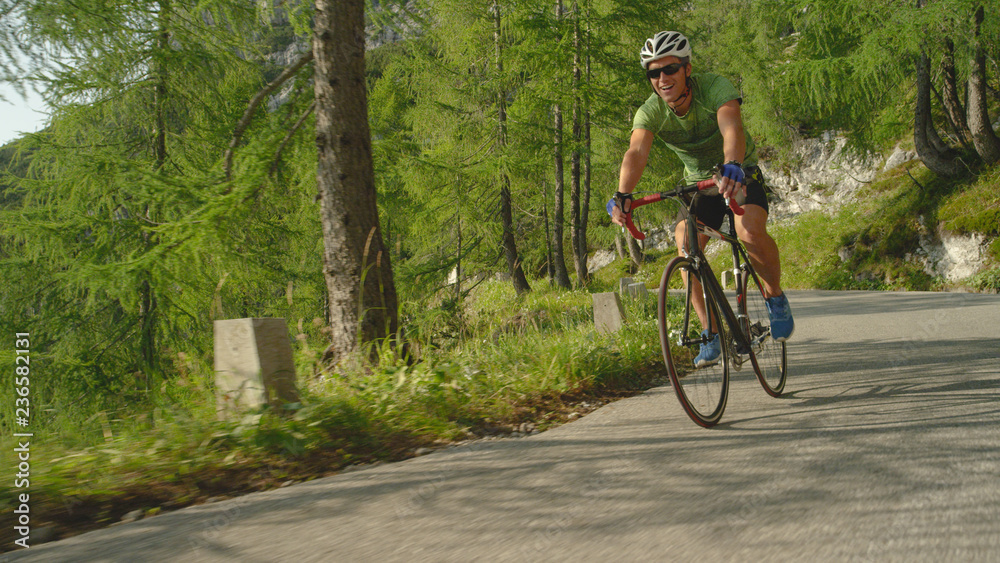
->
215, 318, 299, 419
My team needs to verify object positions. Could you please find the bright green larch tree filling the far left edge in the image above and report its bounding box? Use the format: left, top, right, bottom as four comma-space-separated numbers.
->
2, 0, 320, 414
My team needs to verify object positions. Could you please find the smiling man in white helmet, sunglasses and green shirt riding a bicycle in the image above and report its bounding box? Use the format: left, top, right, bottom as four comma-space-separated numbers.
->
608, 31, 795, 368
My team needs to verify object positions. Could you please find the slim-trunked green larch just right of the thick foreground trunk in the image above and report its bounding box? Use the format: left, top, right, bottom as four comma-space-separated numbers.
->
384, 1, 529, 292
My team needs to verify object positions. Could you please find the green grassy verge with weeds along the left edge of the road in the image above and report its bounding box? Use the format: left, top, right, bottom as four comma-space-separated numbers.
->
0, 278, 680, 550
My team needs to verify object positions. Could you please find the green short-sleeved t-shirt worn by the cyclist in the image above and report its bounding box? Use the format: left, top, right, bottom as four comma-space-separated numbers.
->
632, 73, 757, 182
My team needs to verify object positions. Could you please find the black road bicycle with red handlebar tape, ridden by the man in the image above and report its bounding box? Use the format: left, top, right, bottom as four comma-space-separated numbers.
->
625, 179, 788, 428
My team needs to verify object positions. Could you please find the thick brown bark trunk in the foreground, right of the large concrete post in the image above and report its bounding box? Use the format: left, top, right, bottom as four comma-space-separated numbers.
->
313, 0, 398, 363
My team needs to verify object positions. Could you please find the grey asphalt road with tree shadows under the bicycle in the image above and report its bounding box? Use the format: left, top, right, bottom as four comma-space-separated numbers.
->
7, 292, 1000, 563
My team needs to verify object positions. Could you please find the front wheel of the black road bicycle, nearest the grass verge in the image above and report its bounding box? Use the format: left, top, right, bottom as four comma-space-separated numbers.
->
657, 256, 730, 428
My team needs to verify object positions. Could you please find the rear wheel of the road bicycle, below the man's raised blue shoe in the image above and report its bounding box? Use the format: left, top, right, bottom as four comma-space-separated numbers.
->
739, 268, 788, 397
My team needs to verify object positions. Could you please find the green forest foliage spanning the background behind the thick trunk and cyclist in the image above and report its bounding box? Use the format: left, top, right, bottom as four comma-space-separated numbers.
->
0, 0, 1000, 432
